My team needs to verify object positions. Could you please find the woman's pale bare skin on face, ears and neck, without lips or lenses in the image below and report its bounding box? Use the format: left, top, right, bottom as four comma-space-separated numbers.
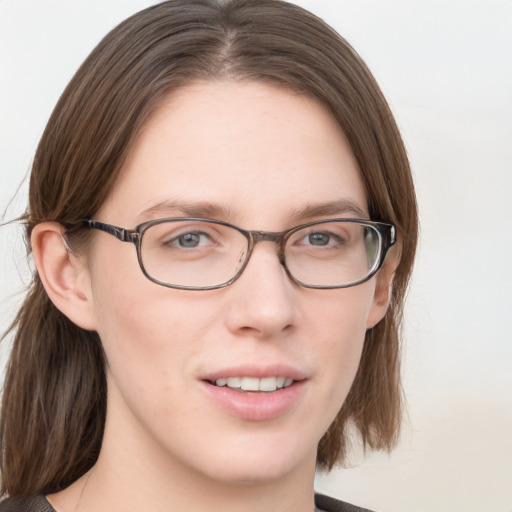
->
32, 81, 392, 512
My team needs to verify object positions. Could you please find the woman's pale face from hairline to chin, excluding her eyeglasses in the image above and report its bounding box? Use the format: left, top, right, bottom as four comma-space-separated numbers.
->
82, 81, 386, 482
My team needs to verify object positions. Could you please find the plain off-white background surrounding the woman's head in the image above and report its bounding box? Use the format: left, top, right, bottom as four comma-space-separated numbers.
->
0, 0, 512, 512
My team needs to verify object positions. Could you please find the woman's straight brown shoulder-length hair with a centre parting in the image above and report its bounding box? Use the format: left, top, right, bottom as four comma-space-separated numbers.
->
0, 0, 418, 497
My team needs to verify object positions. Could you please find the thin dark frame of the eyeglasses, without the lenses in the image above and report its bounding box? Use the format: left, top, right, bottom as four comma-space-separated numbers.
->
83, 217, 396, 290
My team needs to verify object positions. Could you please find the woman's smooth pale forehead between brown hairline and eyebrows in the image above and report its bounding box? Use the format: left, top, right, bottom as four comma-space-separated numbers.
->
101, 81, 367, 229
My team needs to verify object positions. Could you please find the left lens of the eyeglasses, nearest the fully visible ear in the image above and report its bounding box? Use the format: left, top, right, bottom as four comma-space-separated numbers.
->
141, 220, 248, 288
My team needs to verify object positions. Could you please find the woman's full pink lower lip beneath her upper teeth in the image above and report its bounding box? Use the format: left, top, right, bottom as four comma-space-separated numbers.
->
201, 380, 307, 421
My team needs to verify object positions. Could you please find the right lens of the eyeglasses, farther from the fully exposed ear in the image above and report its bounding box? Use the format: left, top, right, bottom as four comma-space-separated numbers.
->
285, 221, 382, 287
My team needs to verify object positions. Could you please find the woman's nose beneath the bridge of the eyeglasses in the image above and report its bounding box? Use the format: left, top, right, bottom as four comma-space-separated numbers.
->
225, 241, 298, 339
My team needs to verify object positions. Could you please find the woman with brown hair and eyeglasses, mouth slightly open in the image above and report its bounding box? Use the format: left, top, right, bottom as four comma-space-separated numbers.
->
0, 0, 417, 512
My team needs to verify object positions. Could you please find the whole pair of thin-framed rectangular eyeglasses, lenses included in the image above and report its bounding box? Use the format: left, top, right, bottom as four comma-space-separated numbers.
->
84, 217, 396, 290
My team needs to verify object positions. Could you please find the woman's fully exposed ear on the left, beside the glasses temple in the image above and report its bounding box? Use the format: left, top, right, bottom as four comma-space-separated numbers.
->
30, 222, 95, 331
